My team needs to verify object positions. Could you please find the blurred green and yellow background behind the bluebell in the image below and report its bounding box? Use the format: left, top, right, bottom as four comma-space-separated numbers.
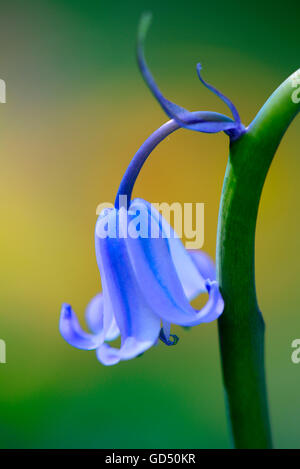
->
0, 0, 300, 448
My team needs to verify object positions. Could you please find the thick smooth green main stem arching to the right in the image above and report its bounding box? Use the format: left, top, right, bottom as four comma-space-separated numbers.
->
217, 70, 300, 448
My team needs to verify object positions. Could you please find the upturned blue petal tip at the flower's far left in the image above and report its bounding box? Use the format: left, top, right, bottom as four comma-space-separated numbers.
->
59, 303, 104, 350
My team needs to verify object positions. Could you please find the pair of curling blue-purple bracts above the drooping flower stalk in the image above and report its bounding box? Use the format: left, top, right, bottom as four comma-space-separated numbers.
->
137, 13, 246, 141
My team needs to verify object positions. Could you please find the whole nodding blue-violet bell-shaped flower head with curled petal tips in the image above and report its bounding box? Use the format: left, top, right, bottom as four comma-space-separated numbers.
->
60, 199, 224, 365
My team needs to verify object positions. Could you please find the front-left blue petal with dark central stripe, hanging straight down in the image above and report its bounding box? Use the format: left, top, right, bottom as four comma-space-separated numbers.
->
95, 207, 160, 364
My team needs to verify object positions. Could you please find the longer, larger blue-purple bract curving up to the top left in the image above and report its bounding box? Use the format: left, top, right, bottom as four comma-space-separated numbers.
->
137, 14, 236, 133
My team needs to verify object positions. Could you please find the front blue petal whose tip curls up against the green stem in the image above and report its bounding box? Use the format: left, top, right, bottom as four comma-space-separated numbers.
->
125, 201, 223, 325
